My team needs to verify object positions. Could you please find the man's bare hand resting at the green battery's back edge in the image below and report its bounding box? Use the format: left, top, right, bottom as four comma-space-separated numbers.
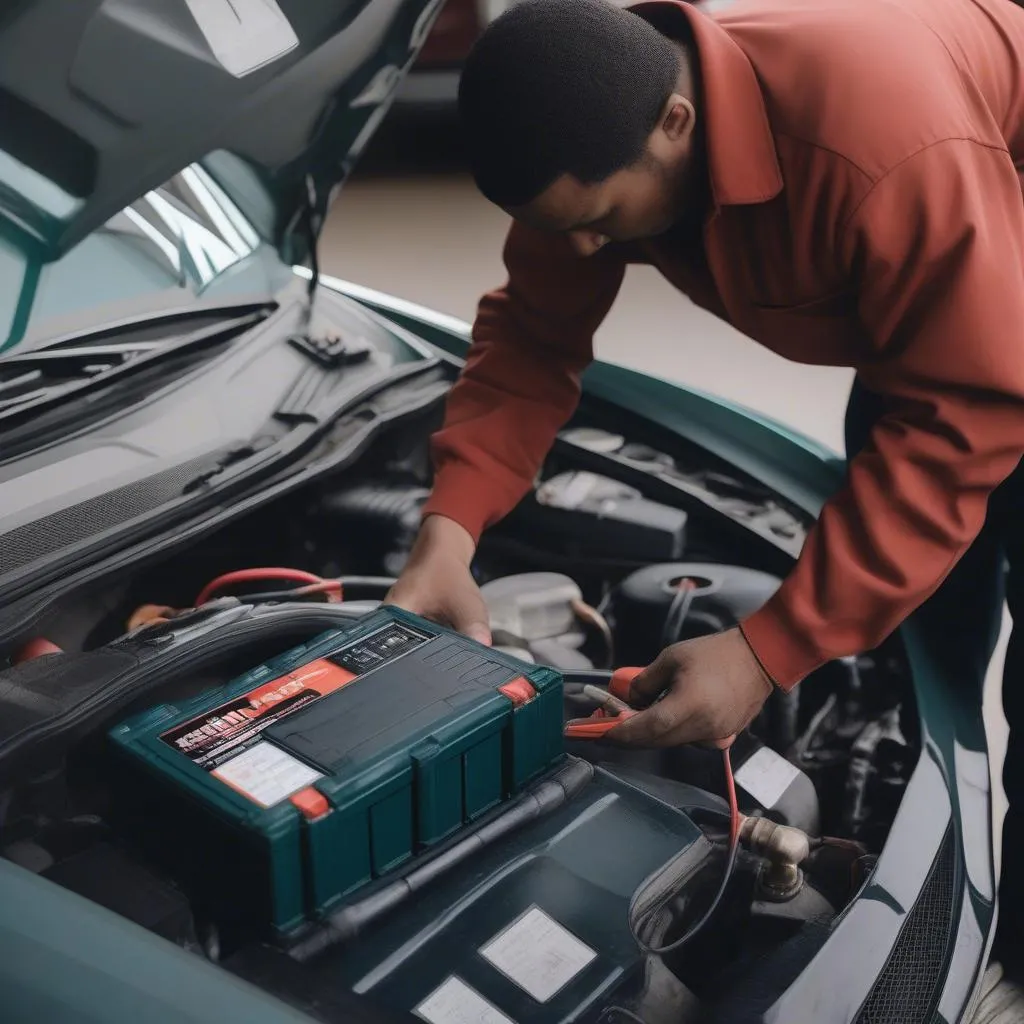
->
385, 515, 490, 645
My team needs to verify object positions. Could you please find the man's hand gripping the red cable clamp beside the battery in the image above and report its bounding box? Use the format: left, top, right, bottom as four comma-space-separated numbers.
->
606, 629, 772, 748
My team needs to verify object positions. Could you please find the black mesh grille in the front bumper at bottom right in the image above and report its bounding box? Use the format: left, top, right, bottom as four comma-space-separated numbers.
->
856, 828, 956, 1024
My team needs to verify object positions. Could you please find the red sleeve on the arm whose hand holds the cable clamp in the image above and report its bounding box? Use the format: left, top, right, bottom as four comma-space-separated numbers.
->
742, 139, 1024, 688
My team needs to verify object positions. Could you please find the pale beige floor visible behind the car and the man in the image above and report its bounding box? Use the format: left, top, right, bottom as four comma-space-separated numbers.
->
322, 105, 1006, 856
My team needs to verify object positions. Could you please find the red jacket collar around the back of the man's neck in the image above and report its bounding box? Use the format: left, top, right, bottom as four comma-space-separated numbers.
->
629, 0, 782, 206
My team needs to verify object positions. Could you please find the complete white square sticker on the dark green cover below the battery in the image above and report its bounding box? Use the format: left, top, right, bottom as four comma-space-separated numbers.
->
480, 906, 597, 1002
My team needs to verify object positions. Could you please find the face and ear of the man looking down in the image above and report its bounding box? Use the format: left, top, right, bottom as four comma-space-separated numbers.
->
509, 96, 698, 256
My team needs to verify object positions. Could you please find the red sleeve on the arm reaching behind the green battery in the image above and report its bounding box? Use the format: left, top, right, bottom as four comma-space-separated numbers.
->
423, 223, 626, 540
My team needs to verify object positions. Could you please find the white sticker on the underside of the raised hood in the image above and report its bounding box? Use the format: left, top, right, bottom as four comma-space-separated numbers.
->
185, 0, 299, 78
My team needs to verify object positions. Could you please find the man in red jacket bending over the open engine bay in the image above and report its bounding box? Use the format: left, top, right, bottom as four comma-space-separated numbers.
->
391, 0, 1024, 963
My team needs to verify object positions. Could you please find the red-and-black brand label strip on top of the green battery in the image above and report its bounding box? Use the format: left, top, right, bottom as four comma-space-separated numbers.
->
160, 659, 356, 771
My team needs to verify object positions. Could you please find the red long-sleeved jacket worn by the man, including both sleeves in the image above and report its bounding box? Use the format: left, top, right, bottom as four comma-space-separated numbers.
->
426, 0, 1024, 686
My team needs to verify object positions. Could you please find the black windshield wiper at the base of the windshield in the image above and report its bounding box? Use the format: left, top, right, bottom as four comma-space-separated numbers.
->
0, 305, 274, 428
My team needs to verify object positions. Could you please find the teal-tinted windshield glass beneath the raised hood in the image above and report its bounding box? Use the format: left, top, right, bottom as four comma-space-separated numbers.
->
0, 154, 287, 358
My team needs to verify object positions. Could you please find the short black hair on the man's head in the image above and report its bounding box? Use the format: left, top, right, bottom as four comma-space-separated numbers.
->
459, 0, 681, 209
